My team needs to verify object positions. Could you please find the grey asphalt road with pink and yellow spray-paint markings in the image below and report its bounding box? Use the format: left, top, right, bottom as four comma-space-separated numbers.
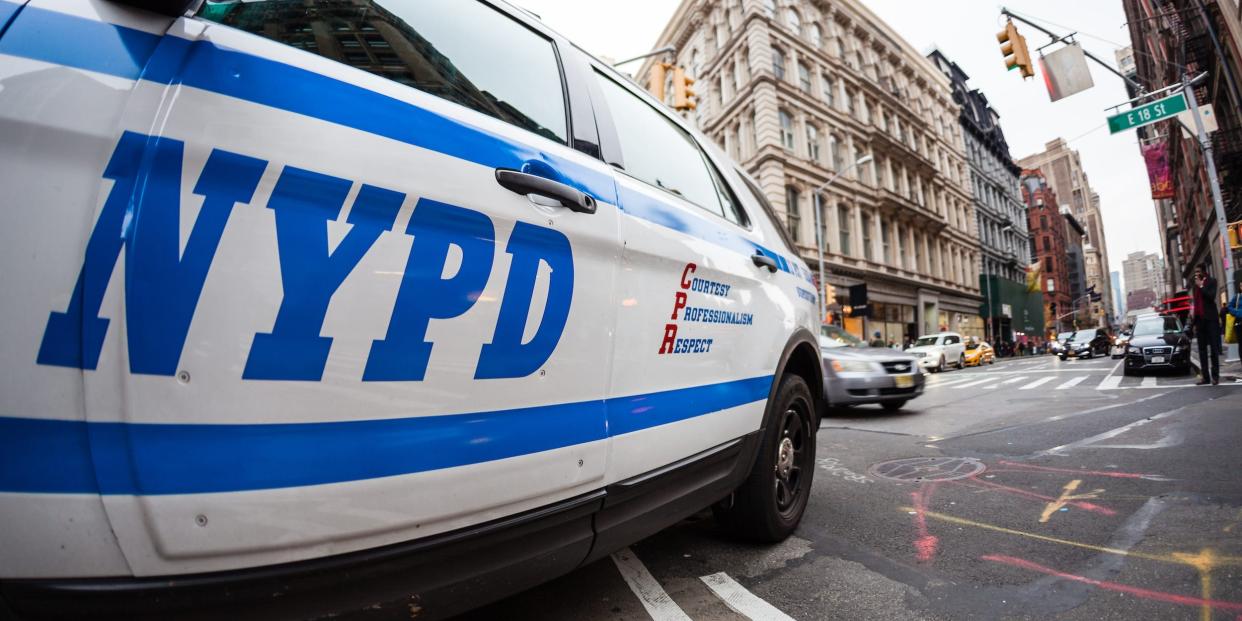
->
467, 356, 1242, 621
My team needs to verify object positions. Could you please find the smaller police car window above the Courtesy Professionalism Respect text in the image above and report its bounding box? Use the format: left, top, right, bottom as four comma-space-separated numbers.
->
596, 73, 735, 217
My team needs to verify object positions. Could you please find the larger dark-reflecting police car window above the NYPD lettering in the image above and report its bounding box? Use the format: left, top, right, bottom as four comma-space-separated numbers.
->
199, 0, 568, 143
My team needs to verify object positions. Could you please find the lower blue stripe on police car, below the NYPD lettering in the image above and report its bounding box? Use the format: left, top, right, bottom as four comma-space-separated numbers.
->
0, 375, 773, 496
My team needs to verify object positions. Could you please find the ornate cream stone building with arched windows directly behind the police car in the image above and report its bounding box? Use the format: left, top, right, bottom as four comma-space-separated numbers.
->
637, 0, 984, 343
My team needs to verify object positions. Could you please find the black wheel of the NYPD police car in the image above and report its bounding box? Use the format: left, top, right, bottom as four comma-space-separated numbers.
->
713, 375, 815, 543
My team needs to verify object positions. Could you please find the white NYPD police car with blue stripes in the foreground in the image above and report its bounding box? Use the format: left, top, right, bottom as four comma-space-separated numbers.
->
0, 0, 823, 619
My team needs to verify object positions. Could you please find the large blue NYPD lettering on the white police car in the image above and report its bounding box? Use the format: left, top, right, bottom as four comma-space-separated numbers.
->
36, 132, 574, 381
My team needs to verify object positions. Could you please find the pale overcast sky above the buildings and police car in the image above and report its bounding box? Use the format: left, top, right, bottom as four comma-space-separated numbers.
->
513, 0, 1163, 284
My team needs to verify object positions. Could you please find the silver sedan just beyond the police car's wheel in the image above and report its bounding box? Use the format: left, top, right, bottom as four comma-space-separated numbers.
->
820, 325, 924, 411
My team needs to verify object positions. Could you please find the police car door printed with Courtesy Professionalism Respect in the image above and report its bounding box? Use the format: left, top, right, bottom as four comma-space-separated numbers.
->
595, 68, 784, 482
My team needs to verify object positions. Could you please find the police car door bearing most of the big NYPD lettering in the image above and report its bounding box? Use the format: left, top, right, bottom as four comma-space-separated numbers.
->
55, 0, 617, 575
